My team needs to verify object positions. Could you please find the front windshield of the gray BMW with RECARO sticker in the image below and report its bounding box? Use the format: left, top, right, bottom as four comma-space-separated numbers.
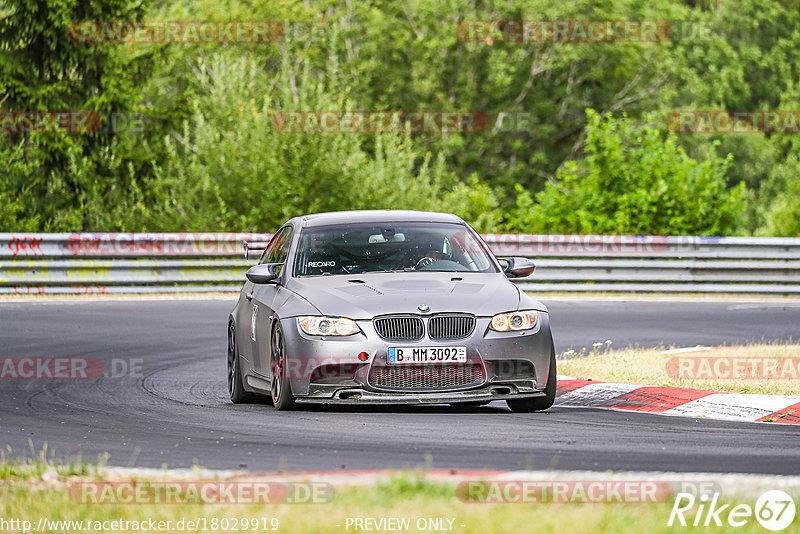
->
295, 223, 497, 276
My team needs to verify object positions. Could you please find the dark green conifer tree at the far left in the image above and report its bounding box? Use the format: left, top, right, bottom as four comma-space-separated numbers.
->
0, 0, 147, 230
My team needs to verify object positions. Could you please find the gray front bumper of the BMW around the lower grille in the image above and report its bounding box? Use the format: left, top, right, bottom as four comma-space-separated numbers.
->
281, 312, 552, 405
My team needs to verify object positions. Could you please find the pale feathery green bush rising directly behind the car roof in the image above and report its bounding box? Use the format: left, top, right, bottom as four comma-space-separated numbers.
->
92, 50, 498, 231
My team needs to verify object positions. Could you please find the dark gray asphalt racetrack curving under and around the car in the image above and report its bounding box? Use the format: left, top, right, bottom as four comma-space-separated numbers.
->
0, 298, 800, 474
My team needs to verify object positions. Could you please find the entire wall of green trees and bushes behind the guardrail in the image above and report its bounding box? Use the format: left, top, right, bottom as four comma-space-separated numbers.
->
0, 0, 800, 235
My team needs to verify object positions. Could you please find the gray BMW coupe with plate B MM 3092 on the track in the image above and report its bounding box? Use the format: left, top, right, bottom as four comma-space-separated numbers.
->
227, 210, 556, 412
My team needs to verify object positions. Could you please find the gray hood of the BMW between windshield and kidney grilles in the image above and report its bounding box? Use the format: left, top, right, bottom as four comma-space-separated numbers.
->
286, 272, 546, 319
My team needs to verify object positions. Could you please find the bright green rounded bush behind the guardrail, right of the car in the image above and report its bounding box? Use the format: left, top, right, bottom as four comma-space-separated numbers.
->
510, 109, 744, 235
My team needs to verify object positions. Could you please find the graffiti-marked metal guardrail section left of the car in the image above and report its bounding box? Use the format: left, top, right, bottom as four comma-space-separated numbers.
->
0, 233, 271, 295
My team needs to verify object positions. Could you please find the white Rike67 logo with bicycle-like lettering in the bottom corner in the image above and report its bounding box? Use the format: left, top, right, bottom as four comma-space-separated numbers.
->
667, 490, 796, 532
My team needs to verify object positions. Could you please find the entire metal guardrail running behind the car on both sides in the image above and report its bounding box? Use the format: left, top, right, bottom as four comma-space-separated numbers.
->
0, 233, 800, 295
